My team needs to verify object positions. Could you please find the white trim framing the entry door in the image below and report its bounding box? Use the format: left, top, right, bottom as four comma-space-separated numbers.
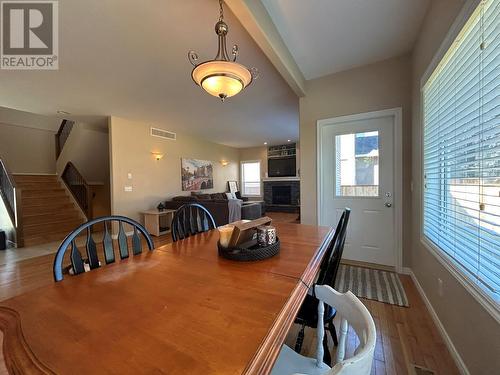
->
316, 107, 403, 273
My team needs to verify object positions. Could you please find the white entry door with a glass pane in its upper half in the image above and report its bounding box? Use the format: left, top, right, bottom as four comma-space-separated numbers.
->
318, 114, 396, 266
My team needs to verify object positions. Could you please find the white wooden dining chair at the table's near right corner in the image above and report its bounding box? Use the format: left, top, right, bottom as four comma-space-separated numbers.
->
271, 285, 376, 375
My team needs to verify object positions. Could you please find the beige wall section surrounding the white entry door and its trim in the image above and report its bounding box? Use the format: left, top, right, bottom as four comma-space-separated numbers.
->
300, 55, 411, 265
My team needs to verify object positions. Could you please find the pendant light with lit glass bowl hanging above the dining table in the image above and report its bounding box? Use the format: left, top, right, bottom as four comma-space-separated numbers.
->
188, 0, 258, 101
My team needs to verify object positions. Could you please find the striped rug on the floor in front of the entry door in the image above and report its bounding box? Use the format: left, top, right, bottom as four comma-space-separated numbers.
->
335, 264, 409, 307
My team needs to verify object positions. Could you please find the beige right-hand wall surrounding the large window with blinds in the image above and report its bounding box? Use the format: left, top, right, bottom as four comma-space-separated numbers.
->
411, 0, 500, 374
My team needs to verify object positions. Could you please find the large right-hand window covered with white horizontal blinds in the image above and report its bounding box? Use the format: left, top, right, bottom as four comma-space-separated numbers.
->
423, 0, 500, 306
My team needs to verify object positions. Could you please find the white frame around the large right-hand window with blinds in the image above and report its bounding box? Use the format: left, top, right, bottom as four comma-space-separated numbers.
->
419, 0, 500, 323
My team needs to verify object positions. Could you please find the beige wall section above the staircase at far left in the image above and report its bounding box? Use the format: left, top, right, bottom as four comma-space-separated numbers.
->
0, 122, 56, 173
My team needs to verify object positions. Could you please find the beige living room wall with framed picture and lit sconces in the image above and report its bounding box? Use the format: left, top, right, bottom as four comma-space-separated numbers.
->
109, 117, 240, 222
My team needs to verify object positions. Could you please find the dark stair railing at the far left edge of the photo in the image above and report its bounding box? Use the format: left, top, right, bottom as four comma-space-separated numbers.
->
0, 159, 24, 247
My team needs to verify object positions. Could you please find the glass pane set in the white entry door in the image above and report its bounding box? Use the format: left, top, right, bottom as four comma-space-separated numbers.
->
335, 131, 379, 197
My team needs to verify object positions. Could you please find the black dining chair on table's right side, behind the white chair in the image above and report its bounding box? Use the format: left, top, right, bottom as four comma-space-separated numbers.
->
295, 207, 351, 364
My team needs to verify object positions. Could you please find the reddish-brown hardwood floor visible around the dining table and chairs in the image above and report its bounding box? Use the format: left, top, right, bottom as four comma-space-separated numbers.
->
0, 228, 459, 375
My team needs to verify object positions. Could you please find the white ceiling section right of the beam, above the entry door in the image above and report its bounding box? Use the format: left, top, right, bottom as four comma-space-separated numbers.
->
261, 0, 429, 79
